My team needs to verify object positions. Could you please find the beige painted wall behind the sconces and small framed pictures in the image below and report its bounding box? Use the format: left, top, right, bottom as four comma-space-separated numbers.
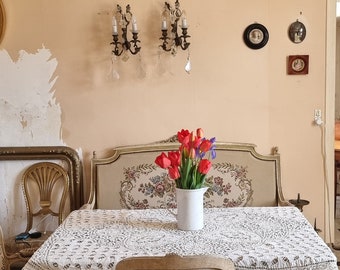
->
0, 0, 334, 240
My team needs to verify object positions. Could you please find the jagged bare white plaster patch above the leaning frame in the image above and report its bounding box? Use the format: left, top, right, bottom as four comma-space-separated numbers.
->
0, 48, 63, 146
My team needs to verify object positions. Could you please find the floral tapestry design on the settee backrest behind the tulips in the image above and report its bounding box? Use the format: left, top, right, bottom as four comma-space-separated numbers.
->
120, 163, 253, 209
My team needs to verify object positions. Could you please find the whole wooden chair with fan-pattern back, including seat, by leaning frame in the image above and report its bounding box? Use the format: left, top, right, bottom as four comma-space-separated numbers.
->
6, 162, 70, 262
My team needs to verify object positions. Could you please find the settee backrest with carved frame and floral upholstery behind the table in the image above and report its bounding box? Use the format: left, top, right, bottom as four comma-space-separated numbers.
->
90, 142, 290, 209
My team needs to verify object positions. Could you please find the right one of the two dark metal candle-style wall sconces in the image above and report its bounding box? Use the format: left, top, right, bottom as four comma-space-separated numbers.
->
159, 0, 190, 55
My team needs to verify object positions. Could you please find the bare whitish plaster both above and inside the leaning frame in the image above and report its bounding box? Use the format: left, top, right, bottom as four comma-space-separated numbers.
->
0, 47, 64, 235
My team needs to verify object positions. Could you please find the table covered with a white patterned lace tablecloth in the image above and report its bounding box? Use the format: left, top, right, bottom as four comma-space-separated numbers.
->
24, 207, 338, 270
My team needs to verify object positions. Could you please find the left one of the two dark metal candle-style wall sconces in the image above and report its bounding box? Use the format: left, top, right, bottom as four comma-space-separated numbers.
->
110, 5, 141, 56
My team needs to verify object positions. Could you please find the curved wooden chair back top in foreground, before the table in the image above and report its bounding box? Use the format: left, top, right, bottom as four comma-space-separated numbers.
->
116, 254, 235, 270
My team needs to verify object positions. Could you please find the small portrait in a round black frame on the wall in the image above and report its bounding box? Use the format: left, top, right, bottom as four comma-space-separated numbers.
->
243, 23, 269, 50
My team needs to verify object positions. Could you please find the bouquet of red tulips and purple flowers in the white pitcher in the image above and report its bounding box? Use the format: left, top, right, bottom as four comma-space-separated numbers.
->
155, 128, 216, 189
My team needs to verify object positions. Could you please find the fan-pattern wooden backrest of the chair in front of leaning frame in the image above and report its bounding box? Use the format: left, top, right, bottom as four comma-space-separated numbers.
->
22, 162, 69, 232
